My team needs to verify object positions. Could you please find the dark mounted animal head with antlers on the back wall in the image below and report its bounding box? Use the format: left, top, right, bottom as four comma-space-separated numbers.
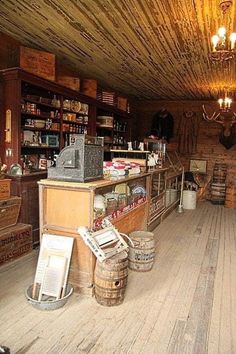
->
202, 105, 236, 149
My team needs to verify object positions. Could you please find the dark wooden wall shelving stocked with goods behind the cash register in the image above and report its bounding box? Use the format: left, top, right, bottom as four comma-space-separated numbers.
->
0, 68, 131, 170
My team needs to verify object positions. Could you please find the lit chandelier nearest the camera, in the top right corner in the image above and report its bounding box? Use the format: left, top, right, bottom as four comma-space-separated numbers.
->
210, 0, 236, 62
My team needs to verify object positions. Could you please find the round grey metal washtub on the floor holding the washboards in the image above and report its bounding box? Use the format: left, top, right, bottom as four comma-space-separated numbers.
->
25, 284, 74, 311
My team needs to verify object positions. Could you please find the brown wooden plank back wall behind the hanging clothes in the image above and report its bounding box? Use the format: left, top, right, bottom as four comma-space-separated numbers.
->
135, 101, 236, 183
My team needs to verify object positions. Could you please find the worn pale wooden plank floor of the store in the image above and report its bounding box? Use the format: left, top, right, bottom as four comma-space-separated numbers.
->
0, 202, 236, 354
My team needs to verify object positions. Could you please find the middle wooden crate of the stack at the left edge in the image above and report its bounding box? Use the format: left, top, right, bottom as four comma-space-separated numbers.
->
0, 197, 21, 230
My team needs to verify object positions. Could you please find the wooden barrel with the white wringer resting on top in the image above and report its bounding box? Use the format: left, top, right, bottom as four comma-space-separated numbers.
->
94, 251, 128, 306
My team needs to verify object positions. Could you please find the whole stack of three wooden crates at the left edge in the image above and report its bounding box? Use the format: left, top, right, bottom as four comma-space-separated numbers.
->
0, 179, 33, 265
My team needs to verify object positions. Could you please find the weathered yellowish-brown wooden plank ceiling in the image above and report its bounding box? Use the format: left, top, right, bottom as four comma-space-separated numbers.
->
0, 0, 236, 100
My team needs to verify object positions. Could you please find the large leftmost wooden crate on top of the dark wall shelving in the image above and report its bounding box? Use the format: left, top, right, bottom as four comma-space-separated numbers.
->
20, 46, 55, 81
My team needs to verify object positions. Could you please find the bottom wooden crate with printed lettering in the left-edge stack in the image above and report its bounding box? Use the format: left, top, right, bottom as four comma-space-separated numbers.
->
0, 224, 33, 265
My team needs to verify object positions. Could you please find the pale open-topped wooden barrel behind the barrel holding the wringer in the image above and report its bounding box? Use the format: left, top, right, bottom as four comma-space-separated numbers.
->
128, 231, 155, 272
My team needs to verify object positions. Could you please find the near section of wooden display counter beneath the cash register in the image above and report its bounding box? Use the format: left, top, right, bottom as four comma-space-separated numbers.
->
39, 174, 150, 293
